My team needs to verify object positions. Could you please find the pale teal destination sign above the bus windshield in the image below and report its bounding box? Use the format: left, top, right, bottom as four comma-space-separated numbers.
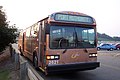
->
55, 13, 93, 23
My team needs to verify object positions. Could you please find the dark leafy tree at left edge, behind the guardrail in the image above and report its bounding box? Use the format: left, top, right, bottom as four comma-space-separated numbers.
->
0, 6, 17, 52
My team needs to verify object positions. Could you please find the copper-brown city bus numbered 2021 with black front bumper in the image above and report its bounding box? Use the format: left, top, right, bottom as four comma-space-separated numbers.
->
18, 11, 100, 74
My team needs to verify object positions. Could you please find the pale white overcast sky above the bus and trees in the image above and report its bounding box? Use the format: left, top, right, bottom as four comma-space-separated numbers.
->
0, 0, 120, 37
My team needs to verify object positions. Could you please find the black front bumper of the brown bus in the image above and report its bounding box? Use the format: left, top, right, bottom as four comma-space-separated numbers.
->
47, 62, 100, 73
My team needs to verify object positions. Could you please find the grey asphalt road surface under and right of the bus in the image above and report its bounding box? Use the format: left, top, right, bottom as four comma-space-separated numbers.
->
39, 51, 120, 80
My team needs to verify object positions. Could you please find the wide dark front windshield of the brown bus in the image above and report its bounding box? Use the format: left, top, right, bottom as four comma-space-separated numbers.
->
50, 26, 96, 49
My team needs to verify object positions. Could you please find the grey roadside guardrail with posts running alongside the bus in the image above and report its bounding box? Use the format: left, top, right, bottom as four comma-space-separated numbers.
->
10, 44, 44, 80
